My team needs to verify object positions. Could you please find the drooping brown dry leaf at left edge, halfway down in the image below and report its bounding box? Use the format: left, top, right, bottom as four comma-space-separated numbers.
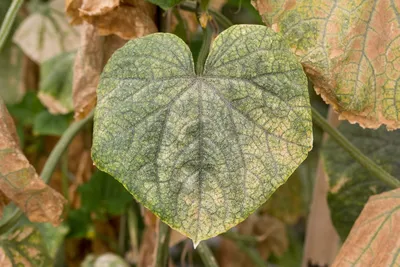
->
0, 100, 66, 225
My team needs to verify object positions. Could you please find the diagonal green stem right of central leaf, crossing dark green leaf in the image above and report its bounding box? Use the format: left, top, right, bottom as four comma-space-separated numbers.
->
312, 108, 400, 188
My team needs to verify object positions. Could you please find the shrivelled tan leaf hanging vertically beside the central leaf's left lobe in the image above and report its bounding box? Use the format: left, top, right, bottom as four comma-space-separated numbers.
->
72, 23, 126, 120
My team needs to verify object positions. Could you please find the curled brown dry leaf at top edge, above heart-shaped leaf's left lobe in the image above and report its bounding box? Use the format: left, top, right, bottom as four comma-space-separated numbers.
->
66, 0, 157, 40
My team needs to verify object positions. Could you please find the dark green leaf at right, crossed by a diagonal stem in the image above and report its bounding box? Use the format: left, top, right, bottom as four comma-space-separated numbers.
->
322, 122, 400, 240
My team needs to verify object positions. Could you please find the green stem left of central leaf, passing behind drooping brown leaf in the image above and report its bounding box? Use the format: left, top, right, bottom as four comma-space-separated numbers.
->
0, 110, 94, 235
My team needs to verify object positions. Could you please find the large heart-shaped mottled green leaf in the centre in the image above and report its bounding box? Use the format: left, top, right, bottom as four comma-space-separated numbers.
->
92, 25, 312, 242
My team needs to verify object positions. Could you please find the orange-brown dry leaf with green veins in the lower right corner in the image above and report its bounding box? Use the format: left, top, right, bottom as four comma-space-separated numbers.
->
332, 189, 400, 267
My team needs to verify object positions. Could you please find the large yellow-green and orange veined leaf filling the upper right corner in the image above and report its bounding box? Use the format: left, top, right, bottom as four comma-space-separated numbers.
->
253, 0, 400, 129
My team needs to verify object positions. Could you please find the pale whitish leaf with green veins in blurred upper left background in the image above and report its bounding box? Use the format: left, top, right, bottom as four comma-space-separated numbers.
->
13, 0, 79, 63
